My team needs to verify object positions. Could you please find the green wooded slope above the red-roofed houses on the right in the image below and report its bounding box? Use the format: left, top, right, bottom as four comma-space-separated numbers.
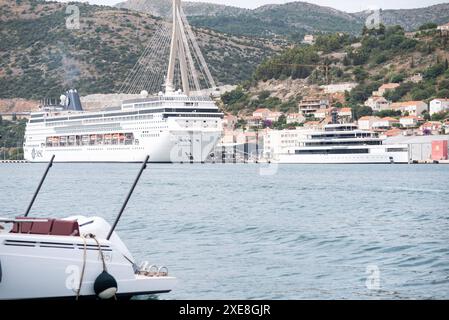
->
222, 24, 449, 116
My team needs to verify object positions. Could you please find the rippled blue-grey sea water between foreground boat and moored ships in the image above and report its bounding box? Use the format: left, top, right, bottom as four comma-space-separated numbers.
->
0, 164, 449, 299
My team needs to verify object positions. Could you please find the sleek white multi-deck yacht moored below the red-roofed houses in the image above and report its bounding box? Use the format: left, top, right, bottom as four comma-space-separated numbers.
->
264, 124, 409, 164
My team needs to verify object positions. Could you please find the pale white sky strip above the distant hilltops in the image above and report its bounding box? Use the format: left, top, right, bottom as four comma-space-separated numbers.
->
61, 0, 447, 12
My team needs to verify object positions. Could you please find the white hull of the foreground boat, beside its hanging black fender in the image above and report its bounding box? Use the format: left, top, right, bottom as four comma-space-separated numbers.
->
0, 218, 176, 300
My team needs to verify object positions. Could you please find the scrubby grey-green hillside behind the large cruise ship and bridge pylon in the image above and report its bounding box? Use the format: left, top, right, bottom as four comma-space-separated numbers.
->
0, 0, 278, 99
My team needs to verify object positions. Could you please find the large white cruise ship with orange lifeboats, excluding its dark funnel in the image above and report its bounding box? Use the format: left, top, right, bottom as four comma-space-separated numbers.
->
24, 94, 223, 162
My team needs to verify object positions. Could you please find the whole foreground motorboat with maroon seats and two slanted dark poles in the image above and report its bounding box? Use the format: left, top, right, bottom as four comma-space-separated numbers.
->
0, 157, 176, 300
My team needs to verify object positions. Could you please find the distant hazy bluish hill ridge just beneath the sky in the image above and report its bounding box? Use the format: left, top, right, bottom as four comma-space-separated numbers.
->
119, 0, 449, 40
